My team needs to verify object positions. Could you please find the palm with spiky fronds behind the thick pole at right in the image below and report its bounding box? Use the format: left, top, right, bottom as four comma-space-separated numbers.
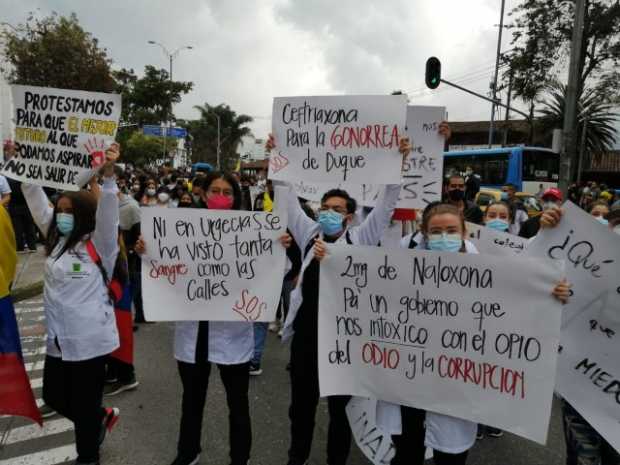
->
539, 81, 620, 157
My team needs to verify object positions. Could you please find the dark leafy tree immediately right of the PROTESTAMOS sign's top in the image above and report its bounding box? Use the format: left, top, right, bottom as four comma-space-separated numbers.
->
113, 65, 194, 126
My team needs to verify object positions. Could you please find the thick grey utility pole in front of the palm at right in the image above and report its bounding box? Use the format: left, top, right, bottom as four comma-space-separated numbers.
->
558, 0, 586, 195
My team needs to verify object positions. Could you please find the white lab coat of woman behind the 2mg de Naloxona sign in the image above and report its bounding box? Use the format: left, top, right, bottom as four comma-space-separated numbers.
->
377, 237, 478, 454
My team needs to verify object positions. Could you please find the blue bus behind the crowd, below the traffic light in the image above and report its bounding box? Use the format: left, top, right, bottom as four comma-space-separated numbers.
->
443, 147, 560, 194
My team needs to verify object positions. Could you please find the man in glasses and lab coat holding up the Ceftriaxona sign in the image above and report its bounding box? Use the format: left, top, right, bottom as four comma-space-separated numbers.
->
266, 124, 422, 465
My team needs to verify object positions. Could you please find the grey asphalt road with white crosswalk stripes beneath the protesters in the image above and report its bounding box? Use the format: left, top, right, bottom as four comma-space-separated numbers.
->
0, 297, 564, 465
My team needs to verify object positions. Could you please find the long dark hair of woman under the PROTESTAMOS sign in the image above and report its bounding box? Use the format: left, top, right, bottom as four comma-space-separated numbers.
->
45, 191, 97, 258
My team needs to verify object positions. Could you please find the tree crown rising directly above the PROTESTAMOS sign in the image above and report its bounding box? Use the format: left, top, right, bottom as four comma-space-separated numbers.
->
2, 13, 115, 92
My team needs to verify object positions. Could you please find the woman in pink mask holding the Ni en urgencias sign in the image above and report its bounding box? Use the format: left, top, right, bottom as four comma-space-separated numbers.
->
136, 172, 290, 465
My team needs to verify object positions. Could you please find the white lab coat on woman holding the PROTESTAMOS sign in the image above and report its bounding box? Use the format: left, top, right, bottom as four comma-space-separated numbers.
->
22, 178, 119, 361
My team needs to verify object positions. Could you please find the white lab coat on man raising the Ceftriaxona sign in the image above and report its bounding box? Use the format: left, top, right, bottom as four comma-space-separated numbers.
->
276, 184, 400, 342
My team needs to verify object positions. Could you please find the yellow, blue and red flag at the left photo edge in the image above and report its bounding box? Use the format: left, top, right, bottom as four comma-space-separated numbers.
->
0, 207, 42, 425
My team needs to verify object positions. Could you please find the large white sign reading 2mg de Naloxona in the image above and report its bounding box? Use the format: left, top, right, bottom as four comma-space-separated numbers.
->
319, 246, 561, 443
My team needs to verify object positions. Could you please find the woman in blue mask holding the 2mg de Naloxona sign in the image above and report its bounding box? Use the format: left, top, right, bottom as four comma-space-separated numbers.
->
368, 203, 570, 465
